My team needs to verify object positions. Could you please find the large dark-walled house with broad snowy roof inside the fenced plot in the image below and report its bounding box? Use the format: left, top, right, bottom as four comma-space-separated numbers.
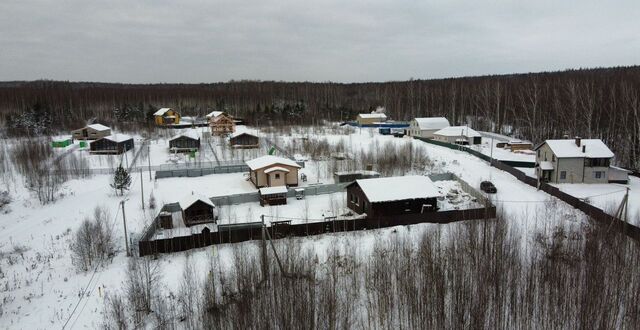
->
346, 175, 440, 217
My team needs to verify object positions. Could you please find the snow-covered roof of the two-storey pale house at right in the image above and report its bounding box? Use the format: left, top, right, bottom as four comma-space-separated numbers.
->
536, 139, 613, 158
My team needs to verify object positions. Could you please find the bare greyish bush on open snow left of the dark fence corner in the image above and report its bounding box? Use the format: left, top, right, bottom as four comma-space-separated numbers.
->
70, 207, 115, 271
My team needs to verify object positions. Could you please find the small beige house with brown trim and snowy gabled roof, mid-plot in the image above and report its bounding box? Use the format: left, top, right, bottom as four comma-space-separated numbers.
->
246, 155, 301, 188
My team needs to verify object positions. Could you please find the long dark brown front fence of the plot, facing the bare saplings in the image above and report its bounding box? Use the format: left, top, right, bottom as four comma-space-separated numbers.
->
138, 206, 496, 256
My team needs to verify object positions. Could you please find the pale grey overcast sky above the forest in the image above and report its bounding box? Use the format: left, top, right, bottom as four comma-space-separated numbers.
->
0, 0, 640, 83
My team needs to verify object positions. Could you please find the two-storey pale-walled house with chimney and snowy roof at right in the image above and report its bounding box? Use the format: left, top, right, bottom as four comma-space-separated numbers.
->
534, 138, 614, 183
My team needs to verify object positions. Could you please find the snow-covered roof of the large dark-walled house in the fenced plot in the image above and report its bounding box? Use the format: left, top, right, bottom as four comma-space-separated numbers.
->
356, 175, 440, 203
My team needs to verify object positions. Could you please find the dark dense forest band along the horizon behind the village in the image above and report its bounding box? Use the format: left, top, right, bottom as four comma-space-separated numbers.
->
0, 66, 640, 168
